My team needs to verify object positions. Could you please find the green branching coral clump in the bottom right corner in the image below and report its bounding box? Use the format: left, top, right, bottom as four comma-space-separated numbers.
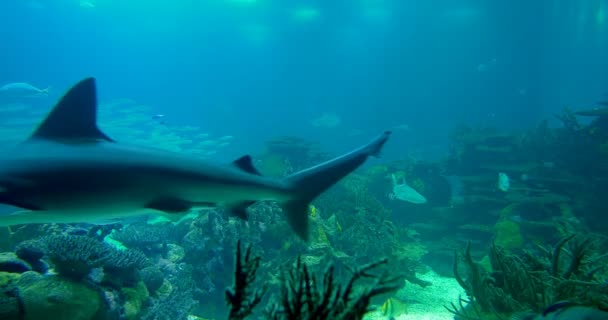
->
448, 235, 608, 319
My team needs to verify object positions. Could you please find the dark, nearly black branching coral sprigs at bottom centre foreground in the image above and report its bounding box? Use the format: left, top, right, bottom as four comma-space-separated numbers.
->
226, 241, 403, 320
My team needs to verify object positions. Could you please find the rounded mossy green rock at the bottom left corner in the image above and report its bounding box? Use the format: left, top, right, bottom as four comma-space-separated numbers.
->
18, 276, 104, 320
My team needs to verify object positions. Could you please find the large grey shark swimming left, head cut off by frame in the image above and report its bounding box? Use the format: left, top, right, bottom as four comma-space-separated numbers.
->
0, 78, 390, 240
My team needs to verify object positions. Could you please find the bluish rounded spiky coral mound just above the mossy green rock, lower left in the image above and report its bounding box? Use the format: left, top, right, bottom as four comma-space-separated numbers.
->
43, 235, 112, 280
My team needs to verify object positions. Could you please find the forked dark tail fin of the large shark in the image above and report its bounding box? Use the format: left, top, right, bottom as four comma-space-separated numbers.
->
282, 131, 391, 240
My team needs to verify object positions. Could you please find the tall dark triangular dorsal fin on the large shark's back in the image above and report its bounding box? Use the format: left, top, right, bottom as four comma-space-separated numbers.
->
30, 78, 114, 142
